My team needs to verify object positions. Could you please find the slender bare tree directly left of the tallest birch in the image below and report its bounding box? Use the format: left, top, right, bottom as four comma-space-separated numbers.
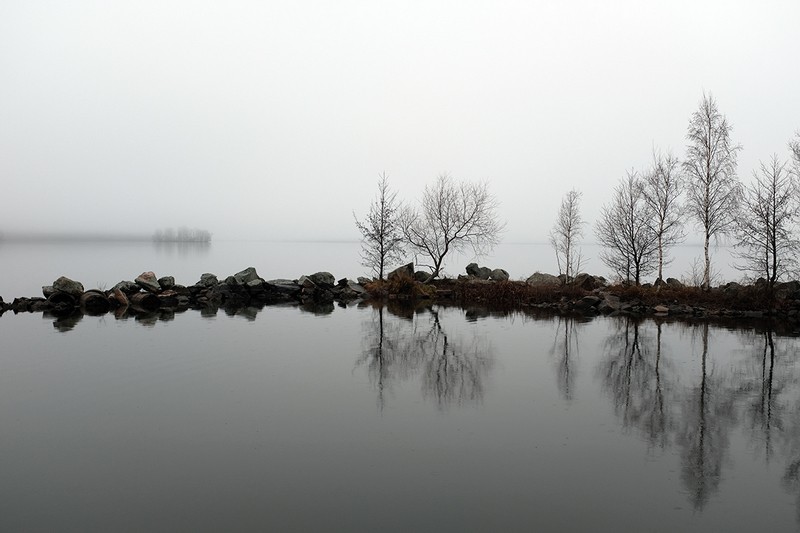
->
642, 150, 686, 280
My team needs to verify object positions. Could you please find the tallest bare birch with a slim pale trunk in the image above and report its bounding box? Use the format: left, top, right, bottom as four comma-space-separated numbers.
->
683, 94, 742, 290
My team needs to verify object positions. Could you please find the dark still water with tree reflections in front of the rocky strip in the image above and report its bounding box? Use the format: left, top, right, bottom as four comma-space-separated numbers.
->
0, 307, 800, 531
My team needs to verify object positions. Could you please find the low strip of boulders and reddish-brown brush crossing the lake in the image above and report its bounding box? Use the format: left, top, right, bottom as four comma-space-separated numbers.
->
0, 263, 800, 330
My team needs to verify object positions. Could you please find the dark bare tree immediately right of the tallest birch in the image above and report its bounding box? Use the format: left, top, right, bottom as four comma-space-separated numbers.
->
735, 155, 800, 292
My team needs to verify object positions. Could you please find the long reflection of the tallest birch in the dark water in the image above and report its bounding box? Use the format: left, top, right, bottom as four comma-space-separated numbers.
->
676, 322, 736, 509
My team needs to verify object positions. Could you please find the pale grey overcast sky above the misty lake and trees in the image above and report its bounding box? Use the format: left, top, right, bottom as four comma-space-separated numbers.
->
0, 0, 800, 242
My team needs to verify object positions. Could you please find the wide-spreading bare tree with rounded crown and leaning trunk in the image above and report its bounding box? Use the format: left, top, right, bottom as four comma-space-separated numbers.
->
401, 174, 505, 283
